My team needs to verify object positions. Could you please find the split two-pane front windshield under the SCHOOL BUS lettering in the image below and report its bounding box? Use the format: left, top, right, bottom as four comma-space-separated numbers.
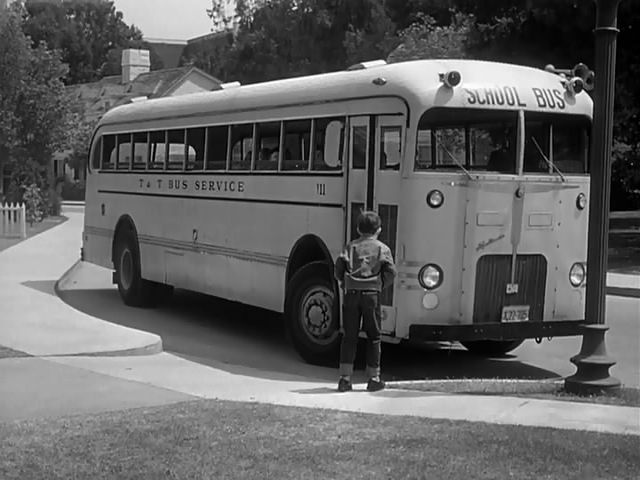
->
414, 109, 589, 174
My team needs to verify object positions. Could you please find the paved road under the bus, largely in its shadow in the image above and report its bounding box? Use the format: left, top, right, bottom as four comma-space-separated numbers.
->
61, 264, 640, 387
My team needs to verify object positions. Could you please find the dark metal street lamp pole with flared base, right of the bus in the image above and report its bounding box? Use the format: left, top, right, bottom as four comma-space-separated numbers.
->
565, 0, 620, 394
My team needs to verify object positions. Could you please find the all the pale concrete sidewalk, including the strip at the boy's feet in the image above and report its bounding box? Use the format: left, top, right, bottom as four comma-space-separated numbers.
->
0, 204, 640, 435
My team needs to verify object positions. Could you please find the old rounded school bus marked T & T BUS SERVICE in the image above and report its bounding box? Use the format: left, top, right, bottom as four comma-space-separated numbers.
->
83, 60, 592, 362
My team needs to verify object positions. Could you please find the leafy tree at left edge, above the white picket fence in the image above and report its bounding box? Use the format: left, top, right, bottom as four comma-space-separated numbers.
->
0, 7, 69, 213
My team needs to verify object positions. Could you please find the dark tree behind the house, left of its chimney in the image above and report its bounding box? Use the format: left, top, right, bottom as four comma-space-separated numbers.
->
23, 0, 162, 84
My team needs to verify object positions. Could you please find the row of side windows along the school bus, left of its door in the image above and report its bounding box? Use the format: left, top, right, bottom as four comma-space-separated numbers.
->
91, 117, 345, 172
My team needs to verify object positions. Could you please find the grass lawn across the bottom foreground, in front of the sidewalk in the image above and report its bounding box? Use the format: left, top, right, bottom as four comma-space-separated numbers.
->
0, 400, 640, 480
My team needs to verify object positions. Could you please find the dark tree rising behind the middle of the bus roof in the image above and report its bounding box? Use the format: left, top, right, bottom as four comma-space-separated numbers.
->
202, 0, 397, 83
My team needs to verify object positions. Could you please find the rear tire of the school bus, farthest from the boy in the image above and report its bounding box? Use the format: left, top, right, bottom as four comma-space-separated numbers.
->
113, 231, 158, 307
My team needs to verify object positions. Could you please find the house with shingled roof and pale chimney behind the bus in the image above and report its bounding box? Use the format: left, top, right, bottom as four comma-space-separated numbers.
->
53, 49, 222, 185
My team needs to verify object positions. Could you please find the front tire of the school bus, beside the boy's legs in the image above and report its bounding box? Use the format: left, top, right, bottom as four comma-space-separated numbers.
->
285, 262, 340, 366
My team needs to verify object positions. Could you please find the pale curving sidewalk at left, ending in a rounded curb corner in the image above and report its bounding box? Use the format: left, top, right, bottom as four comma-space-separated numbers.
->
0, 213, 162, 356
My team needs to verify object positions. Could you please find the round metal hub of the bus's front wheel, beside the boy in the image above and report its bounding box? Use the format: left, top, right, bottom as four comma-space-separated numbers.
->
299, 286, 337, 344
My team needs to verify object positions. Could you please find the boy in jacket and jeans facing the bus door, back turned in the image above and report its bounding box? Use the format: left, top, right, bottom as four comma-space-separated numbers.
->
334, 212, 396, 392
